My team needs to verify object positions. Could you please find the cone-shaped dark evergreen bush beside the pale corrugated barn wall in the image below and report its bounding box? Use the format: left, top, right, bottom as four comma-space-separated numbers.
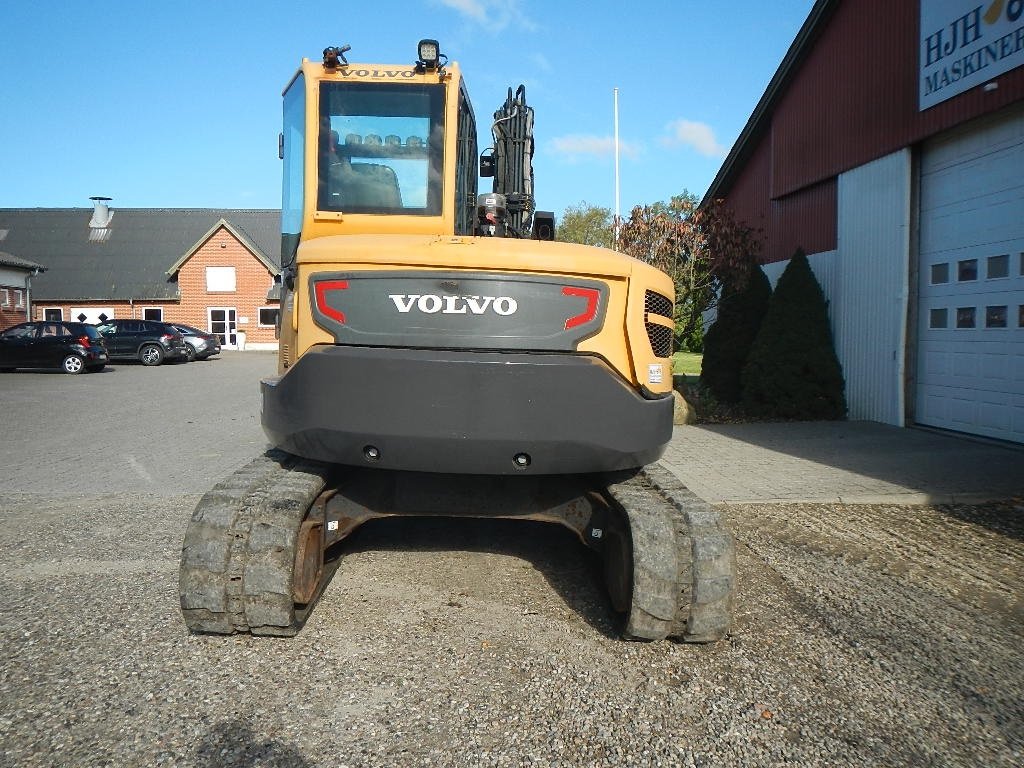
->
742, 249, 846, 419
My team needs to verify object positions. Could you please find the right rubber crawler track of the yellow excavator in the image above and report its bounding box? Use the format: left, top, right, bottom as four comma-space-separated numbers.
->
608, 464, 736, 642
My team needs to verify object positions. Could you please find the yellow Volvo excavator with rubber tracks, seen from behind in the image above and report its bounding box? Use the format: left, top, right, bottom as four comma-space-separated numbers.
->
180, 40, 735, 641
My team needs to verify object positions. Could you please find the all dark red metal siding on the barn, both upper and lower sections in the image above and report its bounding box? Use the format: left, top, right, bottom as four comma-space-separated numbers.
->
726, 0, 1024, 262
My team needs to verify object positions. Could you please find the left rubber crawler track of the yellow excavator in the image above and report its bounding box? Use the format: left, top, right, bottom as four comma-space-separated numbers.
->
178, 451, 329, 636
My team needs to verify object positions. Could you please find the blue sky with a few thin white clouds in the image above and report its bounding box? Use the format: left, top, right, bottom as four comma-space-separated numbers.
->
0, 0, 813, 222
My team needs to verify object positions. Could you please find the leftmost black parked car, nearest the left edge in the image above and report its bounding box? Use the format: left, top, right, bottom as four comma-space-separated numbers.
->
0, 321, 108, 374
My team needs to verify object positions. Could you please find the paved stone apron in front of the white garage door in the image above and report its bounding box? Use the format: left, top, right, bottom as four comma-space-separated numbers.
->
662, 421, 1024, 504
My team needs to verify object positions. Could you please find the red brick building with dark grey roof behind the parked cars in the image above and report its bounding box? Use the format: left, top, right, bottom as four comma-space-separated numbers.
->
0, 207, 281, 349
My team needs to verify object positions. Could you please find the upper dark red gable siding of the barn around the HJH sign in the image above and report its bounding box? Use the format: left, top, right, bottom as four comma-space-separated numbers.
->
771, 0, 1024, 198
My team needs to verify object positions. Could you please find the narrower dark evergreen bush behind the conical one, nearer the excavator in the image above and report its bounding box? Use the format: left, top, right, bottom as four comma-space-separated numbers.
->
700, 267, 771, 402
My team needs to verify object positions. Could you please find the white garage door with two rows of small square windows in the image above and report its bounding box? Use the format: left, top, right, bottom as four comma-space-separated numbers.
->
915, 106, 1024, 442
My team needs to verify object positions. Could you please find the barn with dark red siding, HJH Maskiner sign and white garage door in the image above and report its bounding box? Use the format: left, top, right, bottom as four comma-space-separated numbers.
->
706, 0, 1024, 442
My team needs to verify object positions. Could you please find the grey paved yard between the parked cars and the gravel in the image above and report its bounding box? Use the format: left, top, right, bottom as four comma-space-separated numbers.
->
0, 351, 278, 496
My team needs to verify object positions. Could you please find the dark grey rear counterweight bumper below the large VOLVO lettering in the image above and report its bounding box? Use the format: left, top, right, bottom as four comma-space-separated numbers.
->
260, 346, 674, 474
